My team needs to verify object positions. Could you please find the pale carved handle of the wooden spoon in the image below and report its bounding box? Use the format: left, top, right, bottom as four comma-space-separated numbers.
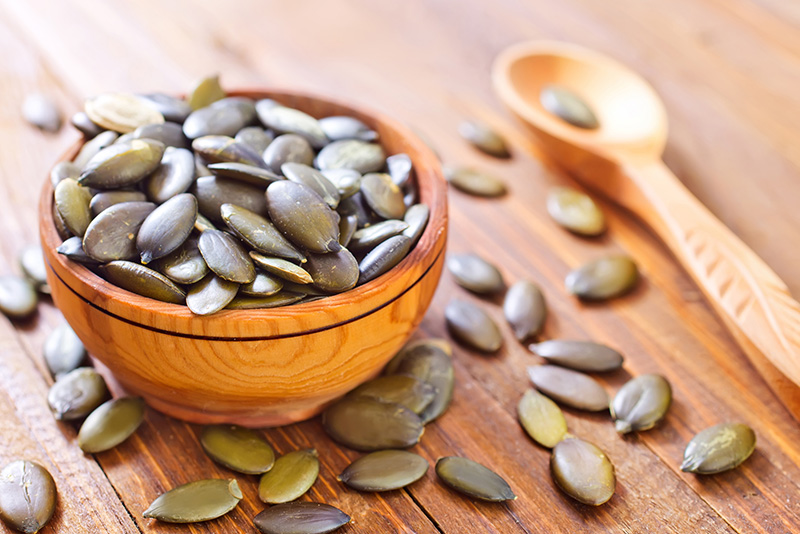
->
621, 161, 800, 414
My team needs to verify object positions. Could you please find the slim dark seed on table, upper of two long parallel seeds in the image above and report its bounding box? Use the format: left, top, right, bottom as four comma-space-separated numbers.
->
529, 339, 623, 373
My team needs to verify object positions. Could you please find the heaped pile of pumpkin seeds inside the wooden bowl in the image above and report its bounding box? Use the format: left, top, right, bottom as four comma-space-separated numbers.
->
51, 77, 430, 315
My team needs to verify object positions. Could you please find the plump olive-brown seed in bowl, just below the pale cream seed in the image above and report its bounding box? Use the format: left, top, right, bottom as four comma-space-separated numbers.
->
78, 139, 166, 189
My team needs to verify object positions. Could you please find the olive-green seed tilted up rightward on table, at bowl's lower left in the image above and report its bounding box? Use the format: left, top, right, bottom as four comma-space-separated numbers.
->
78, 397, 145, 454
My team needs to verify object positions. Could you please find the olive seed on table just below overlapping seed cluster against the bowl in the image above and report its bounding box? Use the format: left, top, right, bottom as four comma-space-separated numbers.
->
336, 450, 428, 491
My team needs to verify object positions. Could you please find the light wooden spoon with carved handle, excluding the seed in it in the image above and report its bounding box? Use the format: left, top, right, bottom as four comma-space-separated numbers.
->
492, 41, 800, 420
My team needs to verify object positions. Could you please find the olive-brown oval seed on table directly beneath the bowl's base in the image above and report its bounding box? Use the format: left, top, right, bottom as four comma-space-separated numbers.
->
200, 425, 275, 475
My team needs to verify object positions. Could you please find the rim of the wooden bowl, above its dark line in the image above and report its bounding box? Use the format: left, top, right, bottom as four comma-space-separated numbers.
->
39, 88, 448, 341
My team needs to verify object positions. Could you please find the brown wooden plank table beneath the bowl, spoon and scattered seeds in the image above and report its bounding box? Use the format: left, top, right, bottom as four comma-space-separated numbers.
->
0, 0, 800, 534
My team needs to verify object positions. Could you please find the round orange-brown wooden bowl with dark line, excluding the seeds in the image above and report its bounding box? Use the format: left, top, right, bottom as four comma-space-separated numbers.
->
39, 91, 447, 426
